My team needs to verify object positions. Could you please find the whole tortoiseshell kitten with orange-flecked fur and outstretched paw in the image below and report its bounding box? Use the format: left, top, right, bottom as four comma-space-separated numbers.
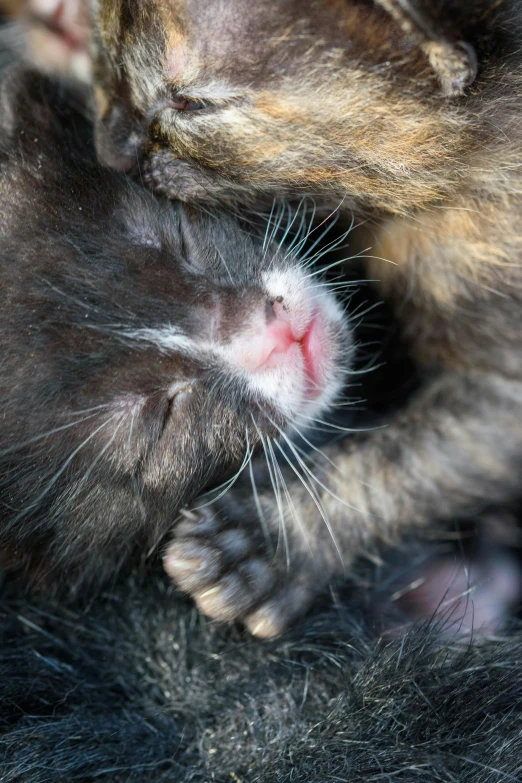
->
78, 0, 522, 636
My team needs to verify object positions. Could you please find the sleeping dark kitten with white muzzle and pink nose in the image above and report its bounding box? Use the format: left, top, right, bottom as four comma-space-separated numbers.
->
0, 68, 353, 585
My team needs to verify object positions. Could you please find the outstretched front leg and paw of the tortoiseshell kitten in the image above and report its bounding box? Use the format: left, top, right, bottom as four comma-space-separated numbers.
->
165, 373, 522, 637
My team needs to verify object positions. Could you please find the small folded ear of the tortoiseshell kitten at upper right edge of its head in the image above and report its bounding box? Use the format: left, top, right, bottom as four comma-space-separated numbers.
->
375, 0, 478, 97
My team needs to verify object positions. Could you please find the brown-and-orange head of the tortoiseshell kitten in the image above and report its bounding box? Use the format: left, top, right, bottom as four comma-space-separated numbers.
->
88, 0, 459, 211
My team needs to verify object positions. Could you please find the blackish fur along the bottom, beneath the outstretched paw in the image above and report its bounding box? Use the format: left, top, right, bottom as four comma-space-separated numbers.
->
0, 571, 522, 783
